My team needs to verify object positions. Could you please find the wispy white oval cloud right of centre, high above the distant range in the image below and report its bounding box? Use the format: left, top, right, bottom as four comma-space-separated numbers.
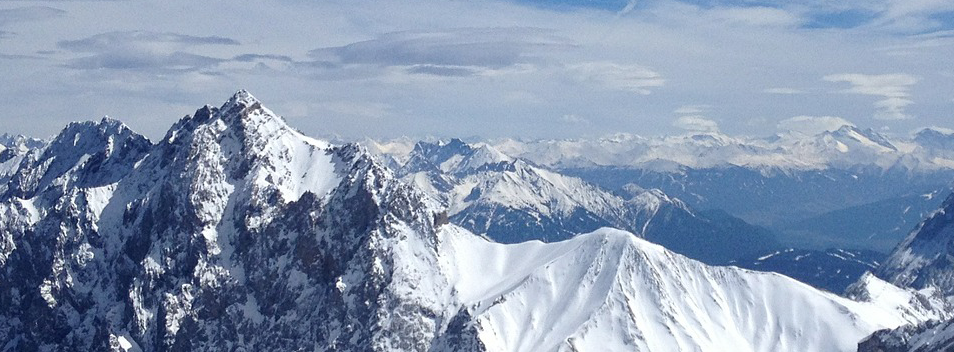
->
567, 61, 666, 95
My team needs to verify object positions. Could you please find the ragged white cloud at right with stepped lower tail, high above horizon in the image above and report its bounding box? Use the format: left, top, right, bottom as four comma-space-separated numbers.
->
824, 73, 918, 120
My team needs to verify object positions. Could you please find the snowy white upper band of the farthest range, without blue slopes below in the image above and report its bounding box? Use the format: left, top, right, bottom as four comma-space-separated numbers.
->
490, 125, 954, 172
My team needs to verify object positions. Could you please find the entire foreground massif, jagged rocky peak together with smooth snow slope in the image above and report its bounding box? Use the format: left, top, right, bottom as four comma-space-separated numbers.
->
0, 91, 936, 351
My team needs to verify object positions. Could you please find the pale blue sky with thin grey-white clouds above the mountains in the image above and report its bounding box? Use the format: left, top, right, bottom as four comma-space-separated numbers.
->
0, 0, 954, 139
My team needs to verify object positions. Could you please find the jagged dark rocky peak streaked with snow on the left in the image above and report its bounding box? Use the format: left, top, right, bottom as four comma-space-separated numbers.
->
0, 92, 446, 351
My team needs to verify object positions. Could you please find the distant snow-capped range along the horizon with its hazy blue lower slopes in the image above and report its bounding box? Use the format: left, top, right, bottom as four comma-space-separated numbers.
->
368, 126, 954, 252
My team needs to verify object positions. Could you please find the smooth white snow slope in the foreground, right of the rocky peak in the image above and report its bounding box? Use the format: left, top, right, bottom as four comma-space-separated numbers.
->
441, 227, 916, 351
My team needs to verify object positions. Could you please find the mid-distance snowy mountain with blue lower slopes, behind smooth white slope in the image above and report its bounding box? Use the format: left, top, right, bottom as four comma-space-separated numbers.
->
401, 139, 779, 264
